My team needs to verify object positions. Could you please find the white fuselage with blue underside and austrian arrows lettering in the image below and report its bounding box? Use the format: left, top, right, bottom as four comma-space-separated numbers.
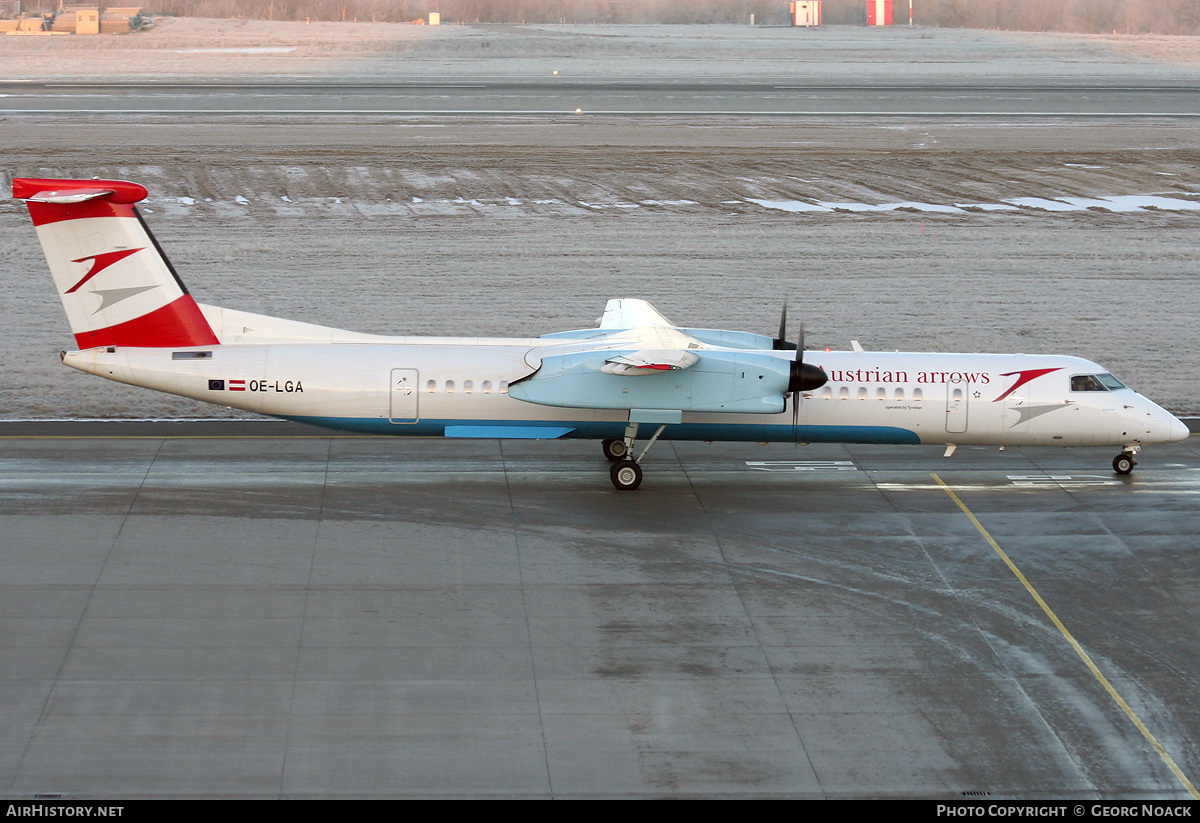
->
64, 335, 1187, 447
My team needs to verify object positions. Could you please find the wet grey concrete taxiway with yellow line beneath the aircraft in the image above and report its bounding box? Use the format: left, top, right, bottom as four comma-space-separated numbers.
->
0, 423, 1200, 799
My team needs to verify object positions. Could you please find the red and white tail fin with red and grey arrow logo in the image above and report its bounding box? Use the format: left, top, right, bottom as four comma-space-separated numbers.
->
12, 178, 218, 349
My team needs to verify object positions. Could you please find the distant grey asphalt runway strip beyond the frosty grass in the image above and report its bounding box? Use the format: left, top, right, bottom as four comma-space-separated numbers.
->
7, 78, 1200, 118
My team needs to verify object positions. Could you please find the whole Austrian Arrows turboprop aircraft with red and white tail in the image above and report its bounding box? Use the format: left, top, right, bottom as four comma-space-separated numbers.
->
13, 179, 1188, 489
